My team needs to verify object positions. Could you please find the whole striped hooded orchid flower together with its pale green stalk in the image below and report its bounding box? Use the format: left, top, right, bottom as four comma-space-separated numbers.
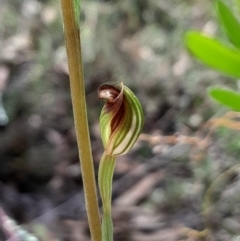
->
98, 83, 144, 241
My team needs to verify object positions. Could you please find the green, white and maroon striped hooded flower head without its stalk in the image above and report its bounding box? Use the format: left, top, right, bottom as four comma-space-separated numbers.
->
98, 83, 144, 156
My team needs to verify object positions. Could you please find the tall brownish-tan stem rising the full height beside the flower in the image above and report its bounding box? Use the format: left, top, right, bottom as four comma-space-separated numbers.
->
62, 0, 101, 241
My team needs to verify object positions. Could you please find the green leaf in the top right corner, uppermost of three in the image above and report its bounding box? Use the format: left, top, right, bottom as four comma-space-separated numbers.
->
217, 1, 240, 48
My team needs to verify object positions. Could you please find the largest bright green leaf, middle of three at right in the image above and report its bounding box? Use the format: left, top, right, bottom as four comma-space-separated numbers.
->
185, 31, 240, 78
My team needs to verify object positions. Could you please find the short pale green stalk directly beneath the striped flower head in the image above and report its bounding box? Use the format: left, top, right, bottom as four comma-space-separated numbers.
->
98, 152, 116, 241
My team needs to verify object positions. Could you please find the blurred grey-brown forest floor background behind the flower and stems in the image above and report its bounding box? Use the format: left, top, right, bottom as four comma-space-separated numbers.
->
0, 0, 240, 241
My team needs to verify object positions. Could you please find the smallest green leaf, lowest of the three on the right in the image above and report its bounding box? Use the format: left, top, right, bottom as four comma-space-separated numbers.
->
208, 87, 240, 111
